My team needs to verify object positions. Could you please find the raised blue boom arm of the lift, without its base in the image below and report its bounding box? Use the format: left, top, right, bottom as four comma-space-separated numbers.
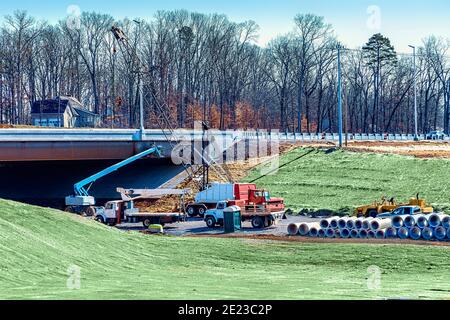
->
73, 147, 161, 197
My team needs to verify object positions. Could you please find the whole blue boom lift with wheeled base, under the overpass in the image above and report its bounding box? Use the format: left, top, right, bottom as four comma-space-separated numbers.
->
66, 147, 161, 216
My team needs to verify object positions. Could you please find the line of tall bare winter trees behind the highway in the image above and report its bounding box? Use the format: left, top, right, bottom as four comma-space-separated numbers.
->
0, 10, 450, 133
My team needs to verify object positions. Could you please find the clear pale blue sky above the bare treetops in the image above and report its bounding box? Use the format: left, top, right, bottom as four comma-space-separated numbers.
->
0, 0, 450, 52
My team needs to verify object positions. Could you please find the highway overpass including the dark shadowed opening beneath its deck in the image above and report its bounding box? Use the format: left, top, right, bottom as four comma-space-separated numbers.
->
0, 129, 246, 208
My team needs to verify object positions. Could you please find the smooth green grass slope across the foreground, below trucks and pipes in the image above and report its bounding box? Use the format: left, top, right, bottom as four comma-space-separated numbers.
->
0, 200, 450, 299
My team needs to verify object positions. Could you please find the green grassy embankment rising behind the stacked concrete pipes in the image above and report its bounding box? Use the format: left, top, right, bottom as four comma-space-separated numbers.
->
246, 148, 450, 211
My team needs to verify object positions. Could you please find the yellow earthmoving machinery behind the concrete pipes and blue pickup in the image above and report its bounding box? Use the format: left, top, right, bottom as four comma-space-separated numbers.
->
355, 194, 433, 218
